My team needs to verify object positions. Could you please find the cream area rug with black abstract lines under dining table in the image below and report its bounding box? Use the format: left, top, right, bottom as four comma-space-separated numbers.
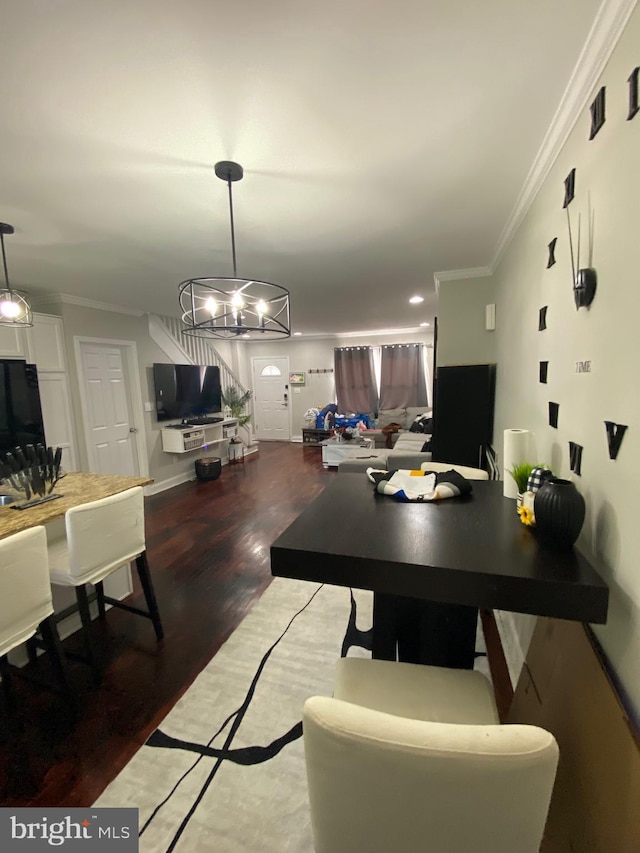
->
95, 578, 490, 853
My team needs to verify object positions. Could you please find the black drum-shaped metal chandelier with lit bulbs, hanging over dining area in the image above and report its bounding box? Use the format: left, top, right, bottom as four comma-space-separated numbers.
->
179, 160, 291, 339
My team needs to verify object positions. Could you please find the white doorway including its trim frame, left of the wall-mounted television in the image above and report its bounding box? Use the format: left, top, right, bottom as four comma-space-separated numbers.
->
74, 337, 149, 477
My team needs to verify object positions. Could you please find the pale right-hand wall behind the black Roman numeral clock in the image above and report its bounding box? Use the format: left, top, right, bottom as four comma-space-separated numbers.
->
438, 9, 640, 717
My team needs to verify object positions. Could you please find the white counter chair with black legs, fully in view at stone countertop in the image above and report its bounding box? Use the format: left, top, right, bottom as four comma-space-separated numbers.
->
49, 486, 164, 677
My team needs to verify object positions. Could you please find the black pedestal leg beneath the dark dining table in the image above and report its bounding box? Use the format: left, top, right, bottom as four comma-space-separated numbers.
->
372, 593, 478, 669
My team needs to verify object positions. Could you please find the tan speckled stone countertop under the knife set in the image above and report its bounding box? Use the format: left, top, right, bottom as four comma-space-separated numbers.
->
0, 472, 153, 539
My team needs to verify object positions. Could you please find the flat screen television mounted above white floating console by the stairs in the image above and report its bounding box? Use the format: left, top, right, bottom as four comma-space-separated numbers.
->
153, 364, 222, 421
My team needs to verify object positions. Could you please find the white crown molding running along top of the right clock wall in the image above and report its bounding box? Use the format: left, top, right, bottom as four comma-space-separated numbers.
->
490, 0, 638, 268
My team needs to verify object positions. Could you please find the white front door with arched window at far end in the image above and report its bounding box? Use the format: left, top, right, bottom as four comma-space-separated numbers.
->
252, 356, 291, 441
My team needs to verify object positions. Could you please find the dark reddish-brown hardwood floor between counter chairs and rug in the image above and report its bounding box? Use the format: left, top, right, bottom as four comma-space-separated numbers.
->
0, 442, 336, 807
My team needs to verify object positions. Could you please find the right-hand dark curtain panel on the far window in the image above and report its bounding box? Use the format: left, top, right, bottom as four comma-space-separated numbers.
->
380, 344, 428, 409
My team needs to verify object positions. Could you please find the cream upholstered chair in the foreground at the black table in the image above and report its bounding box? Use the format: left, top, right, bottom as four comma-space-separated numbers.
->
303, 658, 558, 853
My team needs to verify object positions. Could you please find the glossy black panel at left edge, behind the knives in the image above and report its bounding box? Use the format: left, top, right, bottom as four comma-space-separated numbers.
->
0, 358, 46, 460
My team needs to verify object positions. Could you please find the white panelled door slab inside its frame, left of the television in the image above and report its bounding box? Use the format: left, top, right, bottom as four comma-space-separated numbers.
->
80, 341, 139, 477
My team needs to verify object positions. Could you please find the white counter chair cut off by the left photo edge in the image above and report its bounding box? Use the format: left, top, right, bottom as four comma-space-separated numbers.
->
0, 526, 74, 711
